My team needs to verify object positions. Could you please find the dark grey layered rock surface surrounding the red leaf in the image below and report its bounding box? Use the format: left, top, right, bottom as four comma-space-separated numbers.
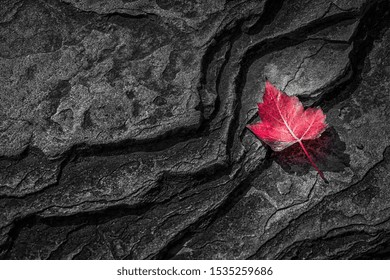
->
0, 0, 390, 259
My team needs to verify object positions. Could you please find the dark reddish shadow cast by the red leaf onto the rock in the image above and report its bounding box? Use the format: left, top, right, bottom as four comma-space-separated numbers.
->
272, 127, 351, 176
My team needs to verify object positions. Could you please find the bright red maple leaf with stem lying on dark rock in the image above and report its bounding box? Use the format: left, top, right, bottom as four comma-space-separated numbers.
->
247, 81, 328, 182
